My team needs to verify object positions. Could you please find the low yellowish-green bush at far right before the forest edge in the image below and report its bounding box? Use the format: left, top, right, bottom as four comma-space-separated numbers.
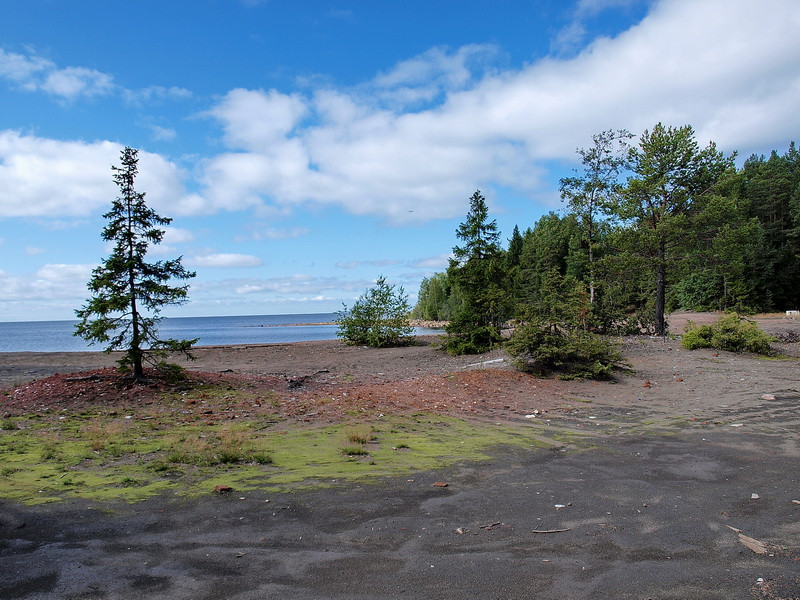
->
681, 314, 775, 354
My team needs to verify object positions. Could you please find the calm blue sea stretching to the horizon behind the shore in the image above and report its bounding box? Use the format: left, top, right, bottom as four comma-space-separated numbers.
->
0, 313, 439, 352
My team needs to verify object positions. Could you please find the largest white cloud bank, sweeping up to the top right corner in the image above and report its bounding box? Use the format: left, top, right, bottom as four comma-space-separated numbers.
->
194, 0, 800, 222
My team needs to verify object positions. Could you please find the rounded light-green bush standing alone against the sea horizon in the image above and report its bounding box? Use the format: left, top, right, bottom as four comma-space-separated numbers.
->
336, 276, 414, 348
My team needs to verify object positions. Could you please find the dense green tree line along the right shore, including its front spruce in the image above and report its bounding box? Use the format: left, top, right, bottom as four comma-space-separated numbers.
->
413, 123, 800, 353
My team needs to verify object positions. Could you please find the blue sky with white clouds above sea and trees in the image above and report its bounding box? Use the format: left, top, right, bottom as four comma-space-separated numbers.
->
0, 0, 800, 321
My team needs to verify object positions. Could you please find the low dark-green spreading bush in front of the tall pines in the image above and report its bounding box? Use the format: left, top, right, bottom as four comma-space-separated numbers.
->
506, 323, 624, 379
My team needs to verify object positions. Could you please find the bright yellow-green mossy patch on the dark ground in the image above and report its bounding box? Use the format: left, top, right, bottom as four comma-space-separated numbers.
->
0, 413, 562, 504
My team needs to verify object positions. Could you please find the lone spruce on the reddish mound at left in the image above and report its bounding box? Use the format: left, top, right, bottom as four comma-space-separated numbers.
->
75, 147, 197, 380
